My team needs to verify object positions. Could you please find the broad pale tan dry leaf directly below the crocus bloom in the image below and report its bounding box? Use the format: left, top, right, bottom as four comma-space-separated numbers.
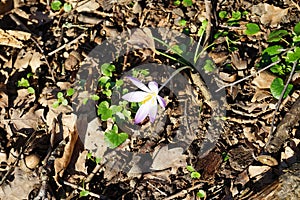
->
151, 146, 186, 170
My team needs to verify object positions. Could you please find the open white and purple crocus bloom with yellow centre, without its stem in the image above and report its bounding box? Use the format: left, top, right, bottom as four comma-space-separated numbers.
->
122, 77, 166, 124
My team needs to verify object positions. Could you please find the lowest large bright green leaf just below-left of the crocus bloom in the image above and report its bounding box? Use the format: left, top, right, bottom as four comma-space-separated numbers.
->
104, 125, 128, 148
